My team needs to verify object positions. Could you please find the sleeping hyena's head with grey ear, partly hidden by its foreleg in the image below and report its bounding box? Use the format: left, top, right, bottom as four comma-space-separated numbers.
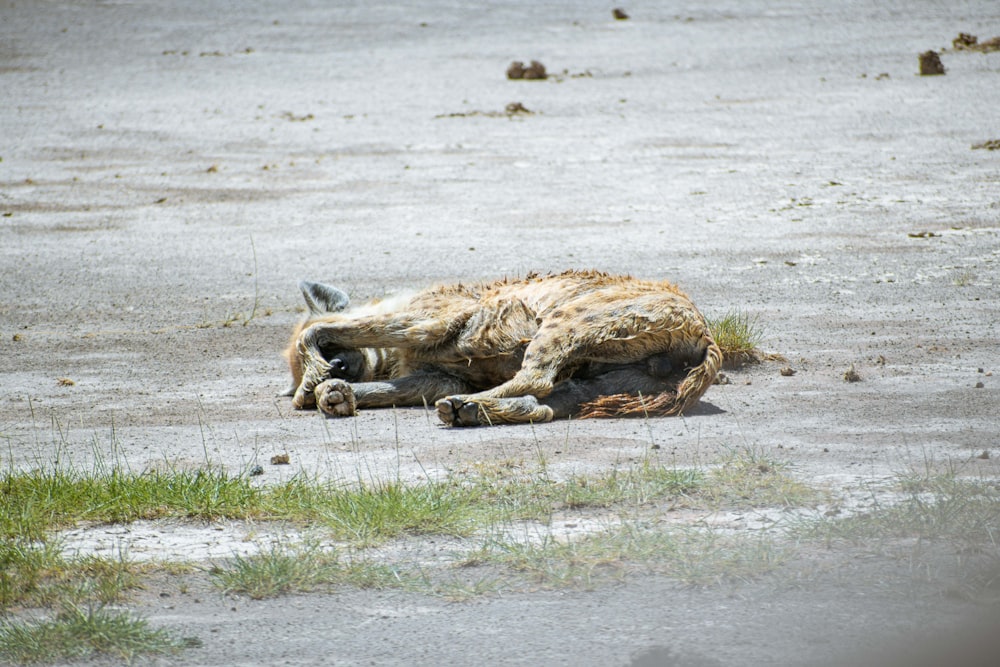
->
282, 280, 368, 407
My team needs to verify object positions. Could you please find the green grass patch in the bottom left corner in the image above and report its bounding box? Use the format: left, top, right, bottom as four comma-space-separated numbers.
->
0, 605, 199, 664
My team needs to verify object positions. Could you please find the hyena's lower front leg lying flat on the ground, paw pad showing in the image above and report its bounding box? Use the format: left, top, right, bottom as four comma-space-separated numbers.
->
315, 372, 470, 417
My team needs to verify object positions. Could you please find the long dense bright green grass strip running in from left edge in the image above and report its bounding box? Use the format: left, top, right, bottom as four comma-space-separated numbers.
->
0, 469, 468, 541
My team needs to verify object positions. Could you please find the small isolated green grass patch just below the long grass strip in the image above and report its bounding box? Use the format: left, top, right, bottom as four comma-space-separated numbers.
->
209, 544, 417, 600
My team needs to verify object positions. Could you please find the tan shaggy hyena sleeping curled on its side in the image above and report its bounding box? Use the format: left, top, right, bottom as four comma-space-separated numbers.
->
285, 271, 722, 426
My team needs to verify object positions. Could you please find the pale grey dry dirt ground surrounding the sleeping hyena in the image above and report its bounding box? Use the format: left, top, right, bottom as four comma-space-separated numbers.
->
0, 0, 1000, 666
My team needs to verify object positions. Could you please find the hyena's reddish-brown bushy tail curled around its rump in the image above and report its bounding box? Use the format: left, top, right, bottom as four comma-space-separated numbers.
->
578, 332, 722, 419
